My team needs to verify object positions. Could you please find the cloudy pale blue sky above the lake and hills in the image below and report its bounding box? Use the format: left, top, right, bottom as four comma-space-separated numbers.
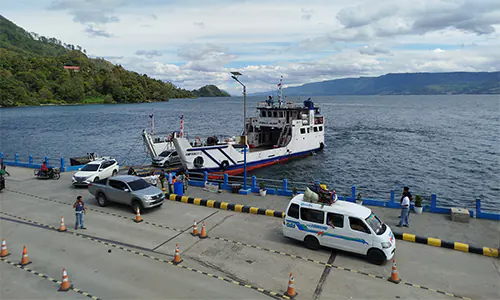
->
0, 0, 500, 95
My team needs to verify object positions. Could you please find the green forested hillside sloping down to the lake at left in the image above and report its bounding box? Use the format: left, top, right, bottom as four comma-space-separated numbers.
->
0, 15, 228, 107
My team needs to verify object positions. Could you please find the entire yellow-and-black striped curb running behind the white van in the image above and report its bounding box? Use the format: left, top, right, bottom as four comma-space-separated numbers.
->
166, 193, 499, 257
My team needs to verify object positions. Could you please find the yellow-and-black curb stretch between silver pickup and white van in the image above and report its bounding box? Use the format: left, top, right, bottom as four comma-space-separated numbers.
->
165, 193, 285, 219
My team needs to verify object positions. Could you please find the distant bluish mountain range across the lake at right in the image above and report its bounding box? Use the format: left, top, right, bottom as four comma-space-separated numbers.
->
251, 72, 500, 96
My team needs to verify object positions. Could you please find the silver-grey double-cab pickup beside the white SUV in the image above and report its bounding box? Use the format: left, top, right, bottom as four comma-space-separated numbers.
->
89, 175, 165, 212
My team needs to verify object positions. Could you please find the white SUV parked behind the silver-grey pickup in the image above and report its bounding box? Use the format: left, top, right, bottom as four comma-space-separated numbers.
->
72, 158, 120, 186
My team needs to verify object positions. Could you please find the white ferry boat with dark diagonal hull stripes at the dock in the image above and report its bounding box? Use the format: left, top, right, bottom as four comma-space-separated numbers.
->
173, 80, 325, 175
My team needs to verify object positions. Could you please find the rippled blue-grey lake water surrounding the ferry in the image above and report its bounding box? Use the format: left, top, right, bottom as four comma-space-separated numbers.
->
0, 95, 500, 211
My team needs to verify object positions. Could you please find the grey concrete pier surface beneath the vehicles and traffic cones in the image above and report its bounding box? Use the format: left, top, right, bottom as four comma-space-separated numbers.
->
0, 167, 500, 299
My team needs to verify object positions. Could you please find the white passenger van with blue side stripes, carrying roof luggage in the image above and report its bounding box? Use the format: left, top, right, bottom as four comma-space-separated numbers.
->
282, 194, 396, 265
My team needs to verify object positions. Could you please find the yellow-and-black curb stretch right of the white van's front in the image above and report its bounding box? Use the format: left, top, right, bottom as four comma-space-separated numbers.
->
394, 232, 498, 257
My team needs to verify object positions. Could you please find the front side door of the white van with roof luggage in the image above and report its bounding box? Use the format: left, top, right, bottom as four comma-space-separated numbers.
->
345, 217, 373, 254
